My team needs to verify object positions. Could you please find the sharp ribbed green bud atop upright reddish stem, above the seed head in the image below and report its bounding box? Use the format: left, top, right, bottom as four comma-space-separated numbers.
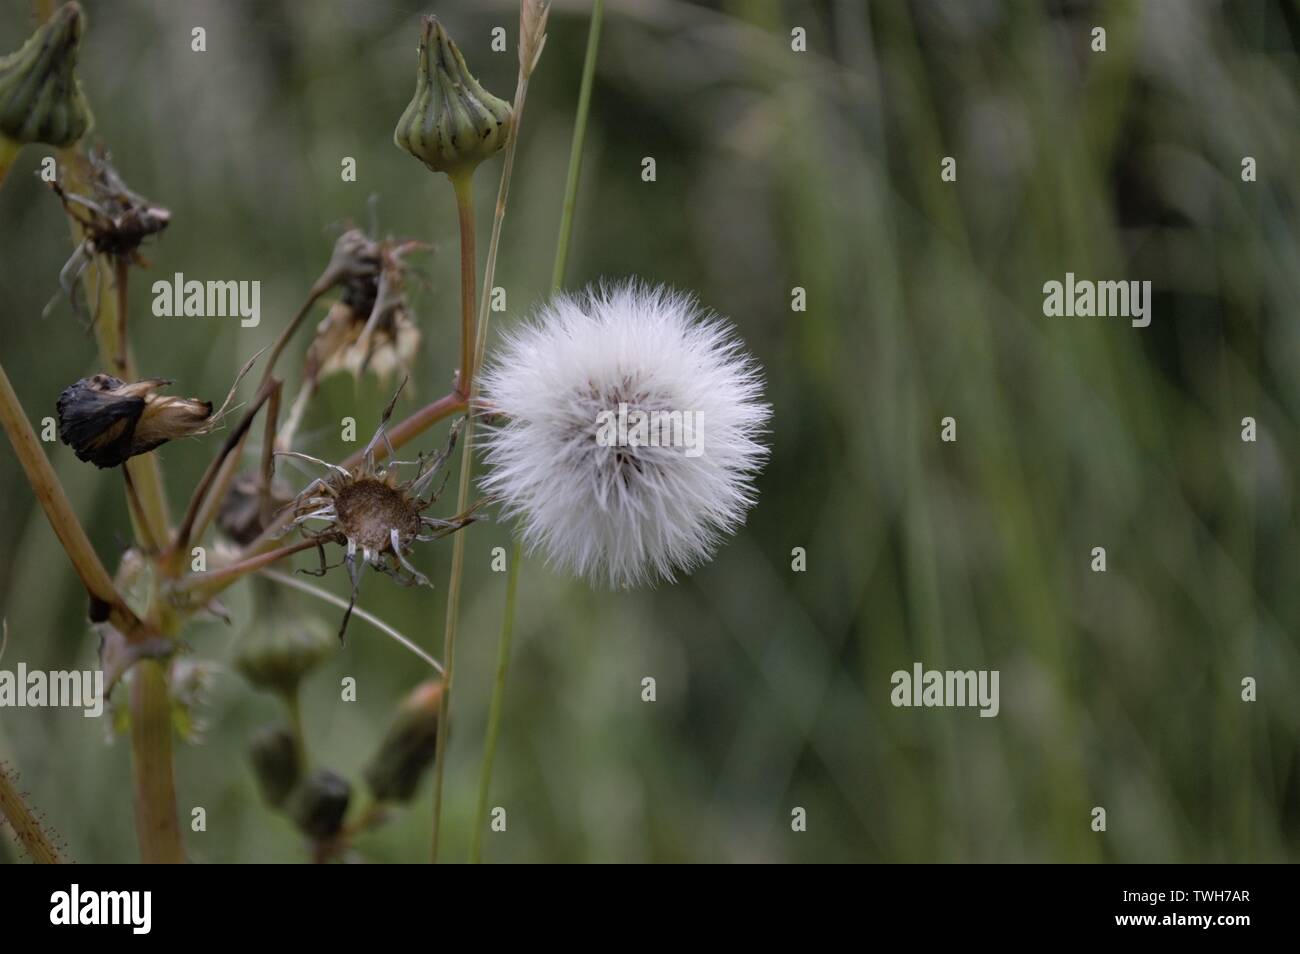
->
393, 17, 514, 175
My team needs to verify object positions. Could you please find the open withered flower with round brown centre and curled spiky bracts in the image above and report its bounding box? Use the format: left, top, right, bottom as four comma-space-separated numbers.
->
277, 387, 477, 639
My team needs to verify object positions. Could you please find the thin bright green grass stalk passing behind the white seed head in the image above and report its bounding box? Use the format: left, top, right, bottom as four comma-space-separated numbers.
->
470, 0, 605, 863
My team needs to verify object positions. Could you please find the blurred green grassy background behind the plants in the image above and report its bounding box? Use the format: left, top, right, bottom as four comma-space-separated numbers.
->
0, 0, 1300, 862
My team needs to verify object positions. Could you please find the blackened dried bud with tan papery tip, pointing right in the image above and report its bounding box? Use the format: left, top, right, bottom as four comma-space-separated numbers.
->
59, 374, 212, 468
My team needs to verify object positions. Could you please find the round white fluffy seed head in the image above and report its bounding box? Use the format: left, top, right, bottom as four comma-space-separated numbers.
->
481, 282, 771, 586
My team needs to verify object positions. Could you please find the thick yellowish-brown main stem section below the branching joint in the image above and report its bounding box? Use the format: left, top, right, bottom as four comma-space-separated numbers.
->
131, 659, 185, 864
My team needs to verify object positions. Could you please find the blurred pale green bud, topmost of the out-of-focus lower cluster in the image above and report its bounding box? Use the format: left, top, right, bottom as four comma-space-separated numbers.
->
235, 577, 337, 695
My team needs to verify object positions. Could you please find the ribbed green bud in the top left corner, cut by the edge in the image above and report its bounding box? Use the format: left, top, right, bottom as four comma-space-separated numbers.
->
0, 3, 91, 147
